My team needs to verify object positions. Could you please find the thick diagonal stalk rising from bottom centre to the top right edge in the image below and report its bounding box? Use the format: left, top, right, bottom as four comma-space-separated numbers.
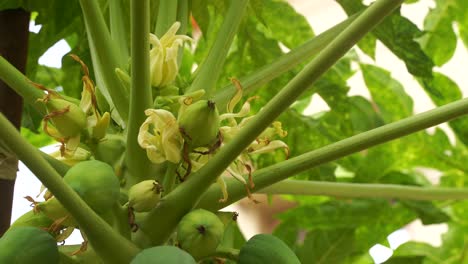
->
141, 0, 403, 244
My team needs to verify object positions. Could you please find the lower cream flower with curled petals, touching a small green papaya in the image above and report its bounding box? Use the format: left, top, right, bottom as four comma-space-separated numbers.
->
138, 109, 184, 163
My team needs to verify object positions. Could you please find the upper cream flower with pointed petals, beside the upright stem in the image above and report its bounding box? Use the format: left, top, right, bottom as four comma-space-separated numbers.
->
150, 22, 192, 87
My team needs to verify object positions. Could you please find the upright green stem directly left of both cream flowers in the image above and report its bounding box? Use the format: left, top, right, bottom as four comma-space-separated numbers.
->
126, 0, 152, 186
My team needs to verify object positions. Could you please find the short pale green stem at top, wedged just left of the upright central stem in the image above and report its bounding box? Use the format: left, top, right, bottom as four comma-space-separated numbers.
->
109, 0, 130, 69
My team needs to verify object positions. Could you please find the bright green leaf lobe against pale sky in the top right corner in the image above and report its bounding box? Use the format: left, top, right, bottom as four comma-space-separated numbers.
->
419, 0, 457, 66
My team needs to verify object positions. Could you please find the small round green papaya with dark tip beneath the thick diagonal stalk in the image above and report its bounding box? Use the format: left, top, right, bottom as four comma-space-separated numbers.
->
177, 209, 224, 260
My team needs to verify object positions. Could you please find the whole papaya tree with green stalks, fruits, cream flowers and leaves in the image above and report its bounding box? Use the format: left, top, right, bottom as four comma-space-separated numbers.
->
0, 0, 468, 263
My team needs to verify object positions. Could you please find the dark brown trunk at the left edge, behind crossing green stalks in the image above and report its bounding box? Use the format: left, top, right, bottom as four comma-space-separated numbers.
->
0, 9, 30, 236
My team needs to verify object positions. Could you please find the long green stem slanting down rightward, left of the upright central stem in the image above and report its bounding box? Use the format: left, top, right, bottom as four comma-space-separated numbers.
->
80, 0, 129, 122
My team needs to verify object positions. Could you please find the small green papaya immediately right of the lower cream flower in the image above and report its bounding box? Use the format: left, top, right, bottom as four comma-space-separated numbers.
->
178, 100, 220, 148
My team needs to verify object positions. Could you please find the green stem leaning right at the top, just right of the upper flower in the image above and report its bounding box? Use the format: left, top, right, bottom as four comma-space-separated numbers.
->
187, 0, 249, 98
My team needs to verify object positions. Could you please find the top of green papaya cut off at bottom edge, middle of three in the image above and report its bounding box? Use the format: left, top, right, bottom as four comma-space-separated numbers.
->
130, 246, 196, 264
